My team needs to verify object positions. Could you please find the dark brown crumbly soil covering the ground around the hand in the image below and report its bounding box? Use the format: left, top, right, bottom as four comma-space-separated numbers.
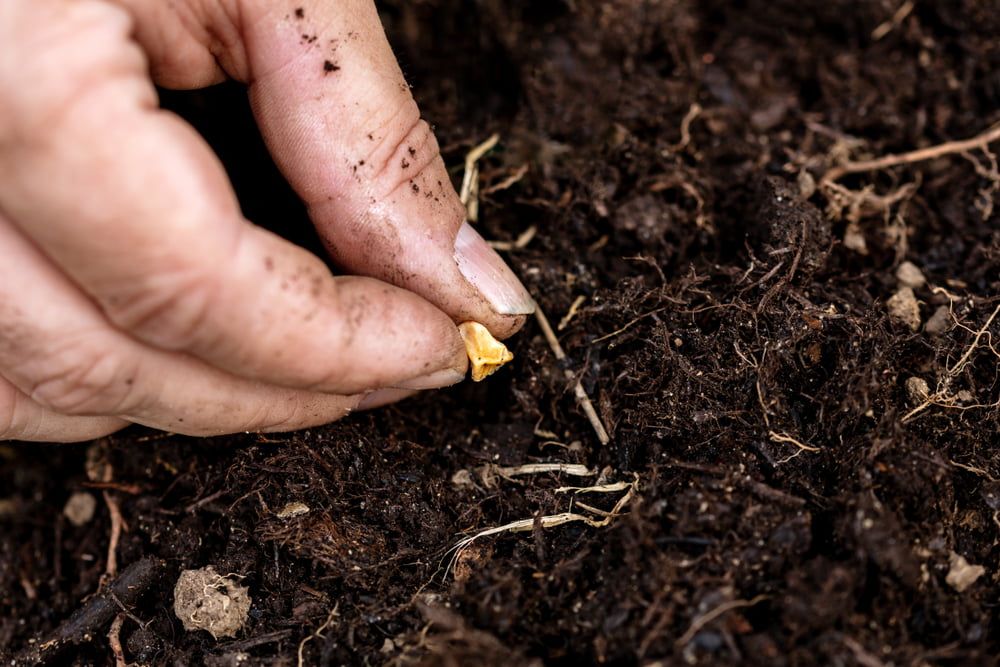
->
0, 0, 1000, 665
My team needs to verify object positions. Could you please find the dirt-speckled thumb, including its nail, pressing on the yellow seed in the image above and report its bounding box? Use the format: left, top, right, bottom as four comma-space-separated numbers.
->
242, 0, 534, 336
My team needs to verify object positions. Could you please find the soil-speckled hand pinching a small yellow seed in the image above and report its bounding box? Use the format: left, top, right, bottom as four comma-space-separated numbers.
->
0, 0, 532, 440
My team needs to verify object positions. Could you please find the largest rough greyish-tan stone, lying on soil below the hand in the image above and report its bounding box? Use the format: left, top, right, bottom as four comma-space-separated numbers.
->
174, 565, 251, 639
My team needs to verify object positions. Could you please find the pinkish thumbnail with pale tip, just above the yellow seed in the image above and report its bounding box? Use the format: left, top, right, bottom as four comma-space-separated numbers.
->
455, 222, 535, 315
